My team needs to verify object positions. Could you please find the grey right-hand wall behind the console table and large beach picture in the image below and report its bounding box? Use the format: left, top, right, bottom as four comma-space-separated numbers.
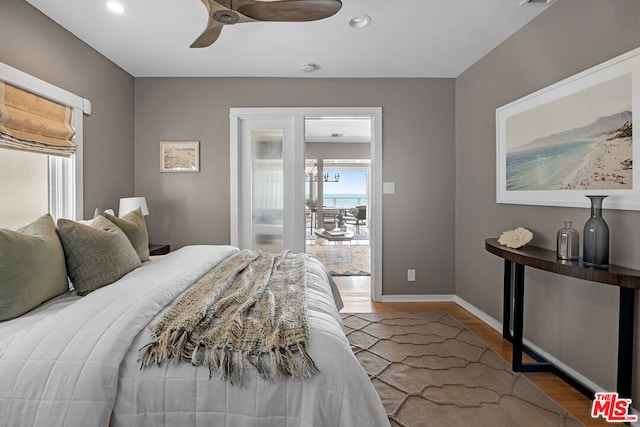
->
455, 0, 640, 400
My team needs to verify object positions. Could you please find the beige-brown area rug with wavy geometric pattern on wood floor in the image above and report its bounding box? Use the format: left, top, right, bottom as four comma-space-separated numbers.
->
341, 312, 583, 427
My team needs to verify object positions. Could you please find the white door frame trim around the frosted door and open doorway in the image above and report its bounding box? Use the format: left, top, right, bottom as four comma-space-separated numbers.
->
229, 107, 383, 301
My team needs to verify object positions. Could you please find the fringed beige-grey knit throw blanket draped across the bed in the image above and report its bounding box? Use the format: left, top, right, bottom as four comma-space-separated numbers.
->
140, 250, 318, 386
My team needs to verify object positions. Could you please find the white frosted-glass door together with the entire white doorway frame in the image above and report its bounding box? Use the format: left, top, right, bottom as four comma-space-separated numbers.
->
229, 107, 383, 301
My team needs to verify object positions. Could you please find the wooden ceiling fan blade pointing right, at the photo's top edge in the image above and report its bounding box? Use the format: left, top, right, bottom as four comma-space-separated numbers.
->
234, 0, 342, 22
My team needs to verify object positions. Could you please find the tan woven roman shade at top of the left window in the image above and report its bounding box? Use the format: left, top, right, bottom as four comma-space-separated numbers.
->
0, 81, 77, 157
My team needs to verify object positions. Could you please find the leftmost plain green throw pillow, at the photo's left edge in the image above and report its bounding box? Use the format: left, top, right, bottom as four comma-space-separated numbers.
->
0, 214, 69, 321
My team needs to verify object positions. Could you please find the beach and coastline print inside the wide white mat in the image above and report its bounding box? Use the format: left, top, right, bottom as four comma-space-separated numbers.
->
506, 73, 633, 191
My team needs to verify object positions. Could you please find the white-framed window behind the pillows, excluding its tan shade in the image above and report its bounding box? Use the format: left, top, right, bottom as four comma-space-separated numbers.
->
0, 62, 91, 229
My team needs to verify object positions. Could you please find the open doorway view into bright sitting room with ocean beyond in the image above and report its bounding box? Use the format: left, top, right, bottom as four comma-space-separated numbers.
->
305, 116, 372, 284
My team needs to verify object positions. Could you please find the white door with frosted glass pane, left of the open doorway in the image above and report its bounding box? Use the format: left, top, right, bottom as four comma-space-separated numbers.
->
231, 115, 304, 252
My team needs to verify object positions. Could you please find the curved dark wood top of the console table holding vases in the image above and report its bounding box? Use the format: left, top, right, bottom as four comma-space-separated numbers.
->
484, 238, 640, 289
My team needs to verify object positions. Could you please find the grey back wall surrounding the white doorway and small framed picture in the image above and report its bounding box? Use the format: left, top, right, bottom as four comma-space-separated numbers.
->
135, 78, 455, 294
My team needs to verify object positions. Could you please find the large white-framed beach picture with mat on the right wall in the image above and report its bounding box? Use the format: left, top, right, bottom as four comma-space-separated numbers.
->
496, 48, 640, 210
